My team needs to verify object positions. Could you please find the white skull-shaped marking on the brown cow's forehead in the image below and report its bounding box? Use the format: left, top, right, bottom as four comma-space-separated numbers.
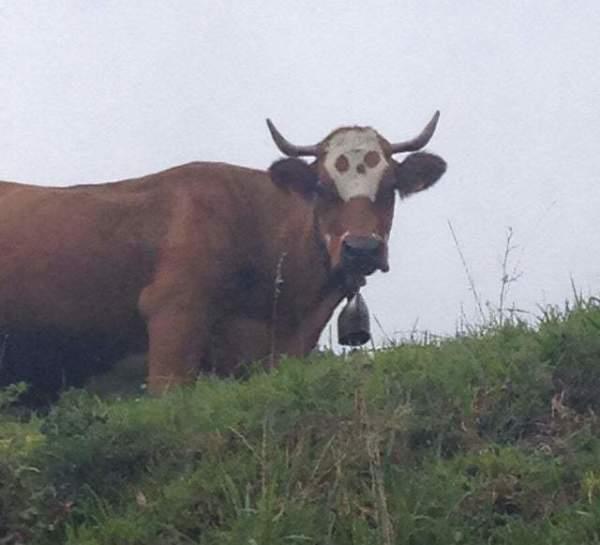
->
324, 128, 388, 202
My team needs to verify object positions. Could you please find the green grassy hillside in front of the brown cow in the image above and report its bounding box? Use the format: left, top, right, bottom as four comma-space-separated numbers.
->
0, 300, 600, 545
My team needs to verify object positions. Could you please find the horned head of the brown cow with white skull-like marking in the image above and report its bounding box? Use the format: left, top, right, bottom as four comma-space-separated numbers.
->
267, 112, 446, 286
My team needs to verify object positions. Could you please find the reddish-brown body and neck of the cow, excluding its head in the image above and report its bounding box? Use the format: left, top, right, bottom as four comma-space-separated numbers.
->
0, 163, 344, 392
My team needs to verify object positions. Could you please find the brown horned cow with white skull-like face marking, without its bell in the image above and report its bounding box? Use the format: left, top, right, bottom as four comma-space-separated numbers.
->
0, 112, 446, 394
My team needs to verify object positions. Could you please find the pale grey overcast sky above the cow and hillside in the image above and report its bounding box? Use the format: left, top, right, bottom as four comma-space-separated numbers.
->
0, 0, 600, 343
